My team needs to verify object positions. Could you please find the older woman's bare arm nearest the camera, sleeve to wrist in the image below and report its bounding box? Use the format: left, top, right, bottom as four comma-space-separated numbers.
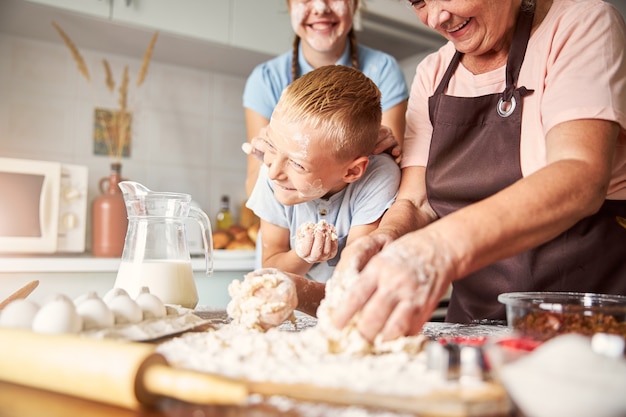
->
430, 119, 619, 279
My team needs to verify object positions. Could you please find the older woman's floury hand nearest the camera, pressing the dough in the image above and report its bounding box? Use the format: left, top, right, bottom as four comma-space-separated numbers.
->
333, 230, 454, 341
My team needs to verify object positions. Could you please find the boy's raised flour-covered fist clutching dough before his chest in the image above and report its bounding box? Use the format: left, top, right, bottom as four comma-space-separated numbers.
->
295, 220, 338, 264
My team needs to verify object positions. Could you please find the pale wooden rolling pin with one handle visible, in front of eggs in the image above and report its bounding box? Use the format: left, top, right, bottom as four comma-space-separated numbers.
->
0, 329, 248, 409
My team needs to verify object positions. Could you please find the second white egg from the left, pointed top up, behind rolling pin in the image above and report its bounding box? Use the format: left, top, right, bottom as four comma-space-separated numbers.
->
32, 294, 83, 334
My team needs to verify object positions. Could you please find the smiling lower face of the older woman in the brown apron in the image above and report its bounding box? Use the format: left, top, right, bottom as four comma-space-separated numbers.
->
410, 0, 521, 61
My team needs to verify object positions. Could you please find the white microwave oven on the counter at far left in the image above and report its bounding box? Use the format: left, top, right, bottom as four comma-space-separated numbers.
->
0, 158, 88, 254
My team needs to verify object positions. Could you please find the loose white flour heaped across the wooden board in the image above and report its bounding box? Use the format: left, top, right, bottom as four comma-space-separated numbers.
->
157, 316, 438, 395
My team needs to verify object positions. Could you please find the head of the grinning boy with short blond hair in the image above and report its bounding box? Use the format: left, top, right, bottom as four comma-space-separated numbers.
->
255, 66, 380, 206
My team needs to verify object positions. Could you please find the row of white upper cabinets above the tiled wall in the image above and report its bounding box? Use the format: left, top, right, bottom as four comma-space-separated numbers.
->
22, 0, 293, 55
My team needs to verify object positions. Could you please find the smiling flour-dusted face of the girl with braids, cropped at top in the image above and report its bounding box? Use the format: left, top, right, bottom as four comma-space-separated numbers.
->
288, 0, 356, 53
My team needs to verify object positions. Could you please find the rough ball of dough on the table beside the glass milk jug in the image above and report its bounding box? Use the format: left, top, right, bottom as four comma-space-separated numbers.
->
226, 268, 298, 331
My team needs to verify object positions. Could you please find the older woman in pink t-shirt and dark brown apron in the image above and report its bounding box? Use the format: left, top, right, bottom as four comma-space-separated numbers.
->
333, 0, 626, 340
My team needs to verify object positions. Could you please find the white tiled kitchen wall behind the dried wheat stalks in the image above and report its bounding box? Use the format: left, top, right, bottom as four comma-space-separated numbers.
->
0, 33, 246, 245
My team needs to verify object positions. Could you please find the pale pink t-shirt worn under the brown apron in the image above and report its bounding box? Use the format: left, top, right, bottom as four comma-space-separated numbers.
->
402, 0, 626, 200
